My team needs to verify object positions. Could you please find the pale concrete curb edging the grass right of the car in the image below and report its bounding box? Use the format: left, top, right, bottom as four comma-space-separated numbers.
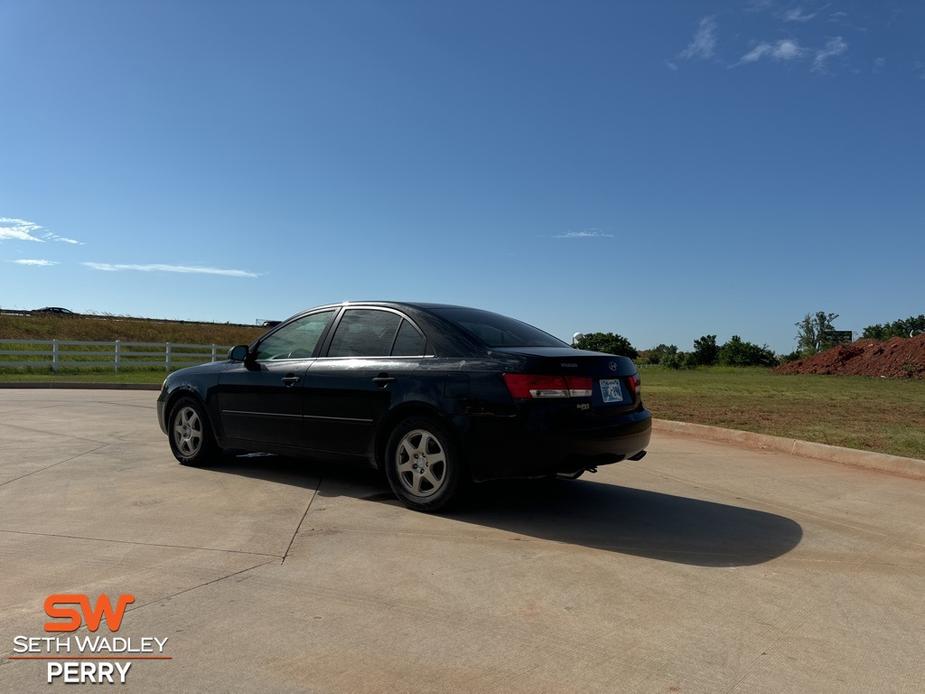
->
652, 419, 925, 479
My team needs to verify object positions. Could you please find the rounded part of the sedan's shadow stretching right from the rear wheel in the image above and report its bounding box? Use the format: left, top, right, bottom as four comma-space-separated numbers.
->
448, 479, 803, 566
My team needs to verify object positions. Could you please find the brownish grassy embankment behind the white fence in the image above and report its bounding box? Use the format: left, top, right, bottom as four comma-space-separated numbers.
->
0, 315, 266, 345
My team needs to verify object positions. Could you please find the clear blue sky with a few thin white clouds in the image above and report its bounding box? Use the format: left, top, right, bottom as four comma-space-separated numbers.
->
0, 0, 925, 351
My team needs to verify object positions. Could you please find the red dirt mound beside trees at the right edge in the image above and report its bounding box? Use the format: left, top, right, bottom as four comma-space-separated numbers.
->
776, 334, 925, 378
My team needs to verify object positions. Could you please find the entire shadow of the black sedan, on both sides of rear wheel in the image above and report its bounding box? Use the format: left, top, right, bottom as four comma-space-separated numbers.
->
214, 456, 803, 567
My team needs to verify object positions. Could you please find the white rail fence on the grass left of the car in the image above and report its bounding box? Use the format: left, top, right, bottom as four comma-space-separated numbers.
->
0, 340, 229, 371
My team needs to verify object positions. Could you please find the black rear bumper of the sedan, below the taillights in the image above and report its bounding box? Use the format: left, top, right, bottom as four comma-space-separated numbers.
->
465, 408, 652, 481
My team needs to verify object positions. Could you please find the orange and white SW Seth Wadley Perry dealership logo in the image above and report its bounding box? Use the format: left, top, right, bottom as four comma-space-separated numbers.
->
9, 593, 172, 684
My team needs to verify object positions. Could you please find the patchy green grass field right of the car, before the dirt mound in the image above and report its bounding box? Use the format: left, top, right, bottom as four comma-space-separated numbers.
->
640, 366, 925, 458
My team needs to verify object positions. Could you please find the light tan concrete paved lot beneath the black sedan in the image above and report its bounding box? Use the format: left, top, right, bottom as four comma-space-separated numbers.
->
0, 390, 925, 692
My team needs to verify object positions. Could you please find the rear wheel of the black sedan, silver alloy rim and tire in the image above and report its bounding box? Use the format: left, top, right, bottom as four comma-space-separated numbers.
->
385, 417, 465, 512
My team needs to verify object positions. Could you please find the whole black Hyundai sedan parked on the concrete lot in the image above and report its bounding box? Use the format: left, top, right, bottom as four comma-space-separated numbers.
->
157, 302, 651, 511
